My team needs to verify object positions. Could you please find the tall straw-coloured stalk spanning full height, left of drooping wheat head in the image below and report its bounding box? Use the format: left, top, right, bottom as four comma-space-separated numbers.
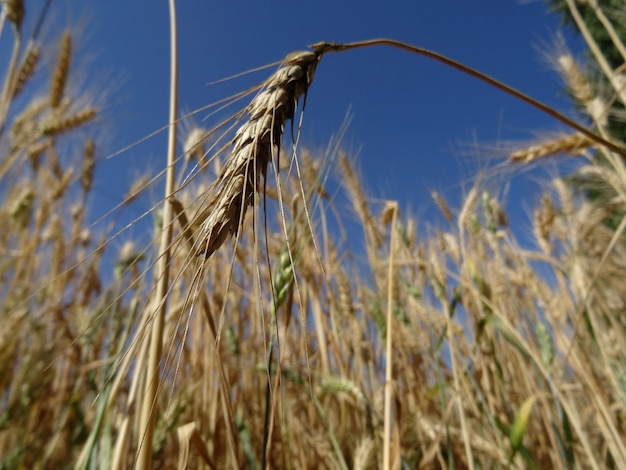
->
137, 0, 178, 470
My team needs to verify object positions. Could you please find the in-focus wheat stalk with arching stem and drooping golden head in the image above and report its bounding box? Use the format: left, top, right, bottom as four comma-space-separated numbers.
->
196, 39, 626, 258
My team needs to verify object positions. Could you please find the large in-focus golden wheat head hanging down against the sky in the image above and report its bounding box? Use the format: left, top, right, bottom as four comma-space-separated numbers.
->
197, 51, 321, 257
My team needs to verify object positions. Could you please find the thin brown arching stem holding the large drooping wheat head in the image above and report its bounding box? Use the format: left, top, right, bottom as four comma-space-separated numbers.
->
310, 39, 626, 158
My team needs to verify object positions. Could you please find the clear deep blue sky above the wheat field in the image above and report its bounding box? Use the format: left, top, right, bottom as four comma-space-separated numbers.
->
42, 0, 572, 239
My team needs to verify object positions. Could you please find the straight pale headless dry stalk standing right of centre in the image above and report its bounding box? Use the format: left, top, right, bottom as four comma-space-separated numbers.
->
383, 202, 398, 470
